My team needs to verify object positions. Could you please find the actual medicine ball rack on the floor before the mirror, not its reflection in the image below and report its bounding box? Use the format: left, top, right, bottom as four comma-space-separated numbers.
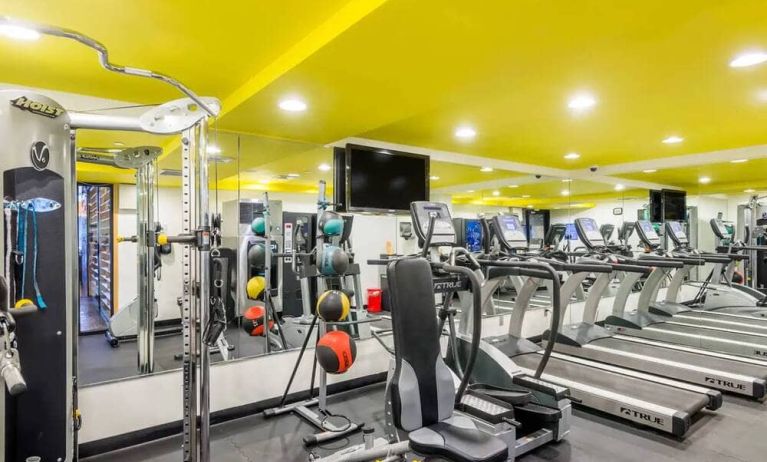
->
264, 181, 374, 446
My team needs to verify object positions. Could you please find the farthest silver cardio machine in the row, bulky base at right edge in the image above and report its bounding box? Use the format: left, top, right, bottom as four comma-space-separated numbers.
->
666, 221, 767, 318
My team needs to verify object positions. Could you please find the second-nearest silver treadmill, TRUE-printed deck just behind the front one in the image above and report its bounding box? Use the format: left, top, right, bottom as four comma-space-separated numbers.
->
494, 217, 767, 400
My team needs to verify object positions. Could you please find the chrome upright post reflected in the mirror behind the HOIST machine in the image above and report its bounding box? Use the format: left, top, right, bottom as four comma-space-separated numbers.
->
136, 161, 156, 374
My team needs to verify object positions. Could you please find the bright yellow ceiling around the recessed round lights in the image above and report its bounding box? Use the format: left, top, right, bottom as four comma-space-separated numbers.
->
0, 0, 767, 199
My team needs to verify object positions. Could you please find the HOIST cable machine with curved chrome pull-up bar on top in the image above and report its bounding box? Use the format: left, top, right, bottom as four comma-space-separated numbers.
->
0, 17, 219, 462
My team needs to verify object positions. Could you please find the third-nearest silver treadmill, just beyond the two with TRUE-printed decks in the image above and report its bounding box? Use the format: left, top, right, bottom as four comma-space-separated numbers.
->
600, 220, 767, 359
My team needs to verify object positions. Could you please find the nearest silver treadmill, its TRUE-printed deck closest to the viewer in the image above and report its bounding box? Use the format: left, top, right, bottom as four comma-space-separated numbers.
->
444, 216, 722, 437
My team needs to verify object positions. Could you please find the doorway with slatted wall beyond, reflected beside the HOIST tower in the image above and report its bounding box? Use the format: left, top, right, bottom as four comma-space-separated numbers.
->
77, 183, 114, 335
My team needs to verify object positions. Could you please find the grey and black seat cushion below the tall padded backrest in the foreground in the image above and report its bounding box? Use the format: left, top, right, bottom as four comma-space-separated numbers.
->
408, 415, 509, 462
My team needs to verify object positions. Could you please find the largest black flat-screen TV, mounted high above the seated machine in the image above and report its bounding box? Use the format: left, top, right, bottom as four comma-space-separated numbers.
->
346, 144, 429, 211
